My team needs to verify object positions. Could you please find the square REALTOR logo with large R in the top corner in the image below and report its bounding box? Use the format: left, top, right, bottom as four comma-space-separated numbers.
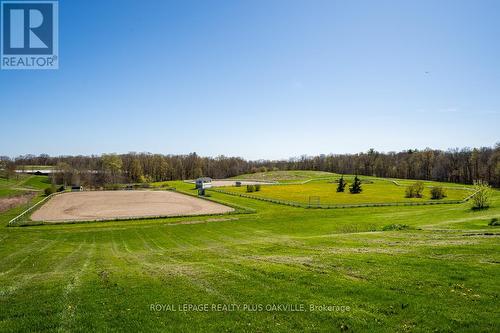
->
0, 0, 59, 70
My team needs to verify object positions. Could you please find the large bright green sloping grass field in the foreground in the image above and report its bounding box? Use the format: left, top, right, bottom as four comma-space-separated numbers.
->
0, 172, 500, 332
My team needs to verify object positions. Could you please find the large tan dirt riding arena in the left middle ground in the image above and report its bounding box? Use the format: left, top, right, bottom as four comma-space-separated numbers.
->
31, 191, 234, 222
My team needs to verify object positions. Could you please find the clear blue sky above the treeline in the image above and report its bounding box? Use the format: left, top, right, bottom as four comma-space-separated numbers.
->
0, 0, 500, 159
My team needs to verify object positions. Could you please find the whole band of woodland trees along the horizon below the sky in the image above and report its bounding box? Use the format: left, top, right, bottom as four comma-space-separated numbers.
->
0, 144, 500, 187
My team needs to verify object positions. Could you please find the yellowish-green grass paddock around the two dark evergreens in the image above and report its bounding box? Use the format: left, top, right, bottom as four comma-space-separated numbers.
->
219, 177, 473, 205
